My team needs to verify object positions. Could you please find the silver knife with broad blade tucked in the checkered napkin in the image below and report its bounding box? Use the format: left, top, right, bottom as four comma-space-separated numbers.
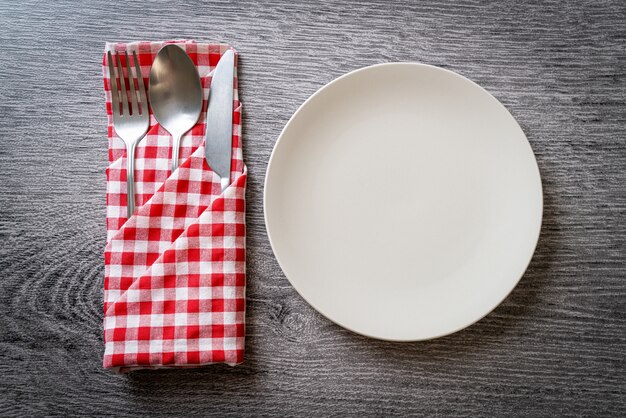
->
204, 49, 235, 191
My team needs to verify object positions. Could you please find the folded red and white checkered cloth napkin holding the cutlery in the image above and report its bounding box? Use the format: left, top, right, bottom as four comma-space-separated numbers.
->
103, 41, 246, 372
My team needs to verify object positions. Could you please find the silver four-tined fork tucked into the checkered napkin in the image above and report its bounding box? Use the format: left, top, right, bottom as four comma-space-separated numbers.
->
107, 51, 150, 218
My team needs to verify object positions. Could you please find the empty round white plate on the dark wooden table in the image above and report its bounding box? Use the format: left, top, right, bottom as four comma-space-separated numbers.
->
264, 63, 543, 341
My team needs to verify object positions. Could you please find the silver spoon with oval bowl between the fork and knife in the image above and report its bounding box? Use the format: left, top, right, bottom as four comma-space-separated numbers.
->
148, 44, 202, 172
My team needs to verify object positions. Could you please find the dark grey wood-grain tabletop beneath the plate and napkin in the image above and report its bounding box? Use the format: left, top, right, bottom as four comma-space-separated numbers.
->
0, 0, 626, 416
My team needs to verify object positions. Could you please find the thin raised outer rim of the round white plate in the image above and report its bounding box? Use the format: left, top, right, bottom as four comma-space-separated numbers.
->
263, 61, 544, 343
